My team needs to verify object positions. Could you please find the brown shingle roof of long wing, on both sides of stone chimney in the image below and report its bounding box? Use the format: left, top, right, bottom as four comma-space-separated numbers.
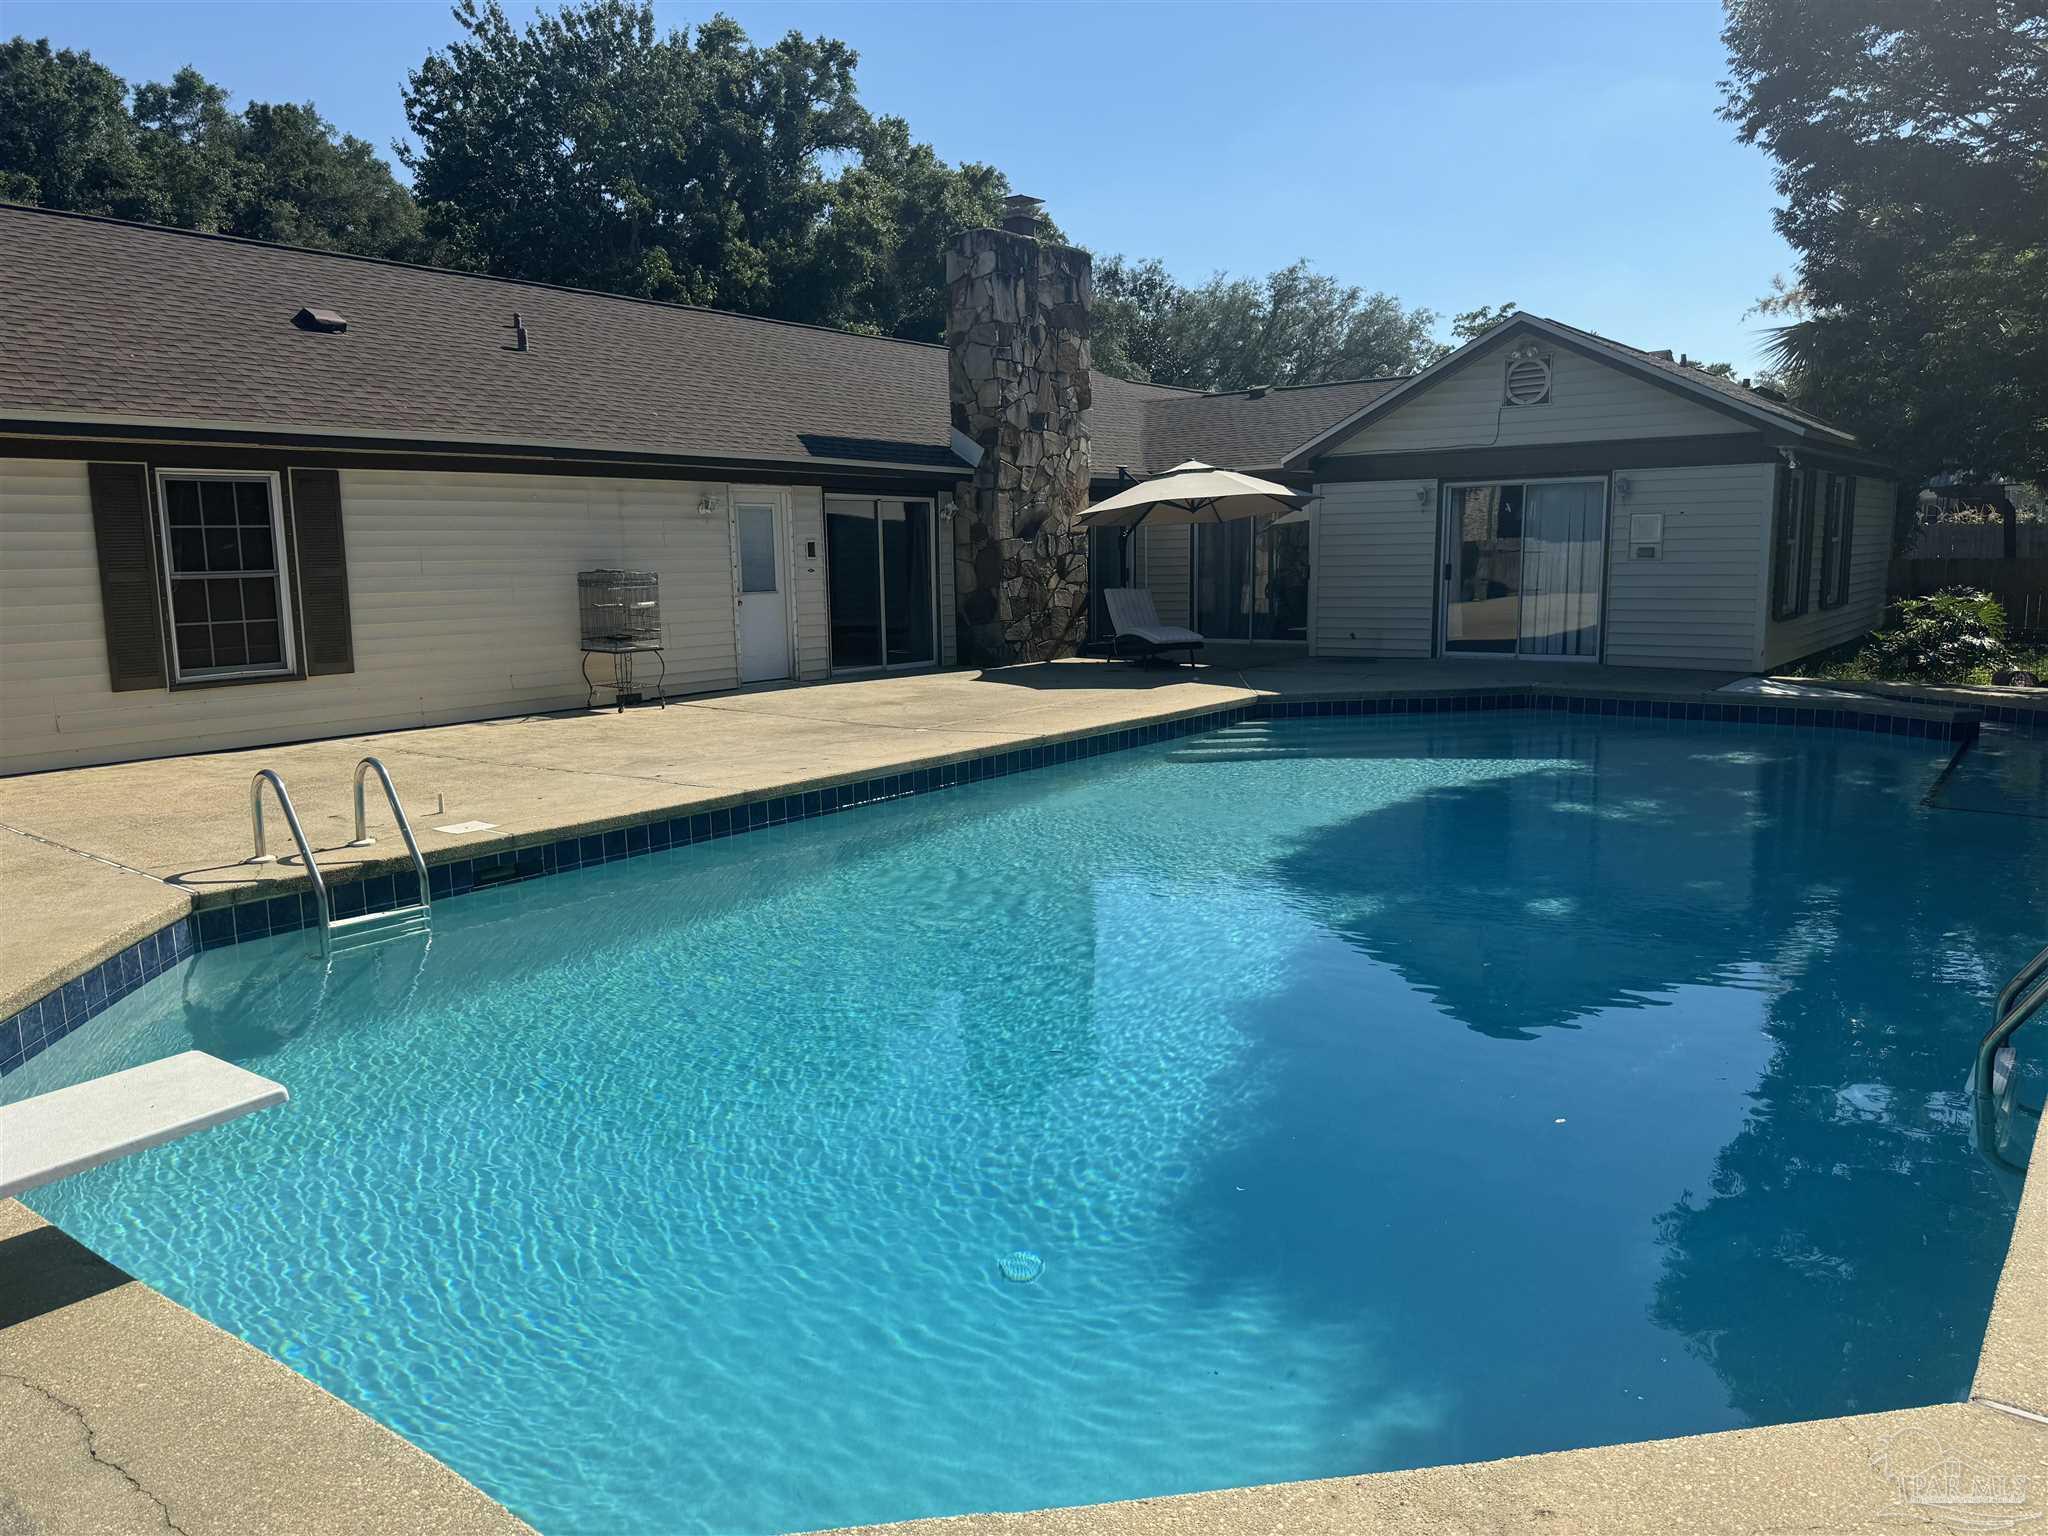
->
0, 205, 1395, 475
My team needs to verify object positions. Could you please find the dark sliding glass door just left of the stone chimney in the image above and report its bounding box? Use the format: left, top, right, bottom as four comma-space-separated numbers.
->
825, 496, 938, 672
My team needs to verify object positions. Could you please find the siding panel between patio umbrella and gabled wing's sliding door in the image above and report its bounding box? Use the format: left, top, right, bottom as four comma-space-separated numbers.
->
1309, 479, 1438, 655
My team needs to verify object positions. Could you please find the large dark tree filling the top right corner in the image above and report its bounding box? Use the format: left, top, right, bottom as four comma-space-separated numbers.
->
1722, 0, 2048, 479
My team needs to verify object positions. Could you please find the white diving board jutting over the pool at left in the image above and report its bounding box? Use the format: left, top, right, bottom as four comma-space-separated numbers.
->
0, 1051, 287, 1200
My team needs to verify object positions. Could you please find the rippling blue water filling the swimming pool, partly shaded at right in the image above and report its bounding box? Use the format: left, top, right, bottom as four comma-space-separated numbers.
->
4, 715, 2048, 1532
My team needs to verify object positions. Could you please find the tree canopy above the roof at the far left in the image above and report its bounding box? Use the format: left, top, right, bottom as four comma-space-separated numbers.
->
0, 37, 420, 256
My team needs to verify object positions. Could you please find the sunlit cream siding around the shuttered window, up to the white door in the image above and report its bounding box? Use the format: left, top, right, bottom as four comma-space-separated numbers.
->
0, 461, 770, 772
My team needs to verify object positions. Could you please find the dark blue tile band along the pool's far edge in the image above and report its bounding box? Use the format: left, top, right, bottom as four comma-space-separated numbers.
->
0, 686, 1982, 1077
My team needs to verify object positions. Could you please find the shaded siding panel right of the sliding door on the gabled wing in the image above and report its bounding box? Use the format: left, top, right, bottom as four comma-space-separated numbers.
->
1604, 465, 1774, 672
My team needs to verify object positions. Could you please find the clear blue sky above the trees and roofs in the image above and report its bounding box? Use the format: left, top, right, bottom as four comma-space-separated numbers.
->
0, 0, 1792, 371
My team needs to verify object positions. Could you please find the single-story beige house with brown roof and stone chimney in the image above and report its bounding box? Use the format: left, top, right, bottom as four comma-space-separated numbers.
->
0, 205, 1894, 772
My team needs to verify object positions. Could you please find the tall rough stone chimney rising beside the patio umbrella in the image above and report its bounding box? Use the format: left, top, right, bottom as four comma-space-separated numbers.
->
946, 197, 1092, 666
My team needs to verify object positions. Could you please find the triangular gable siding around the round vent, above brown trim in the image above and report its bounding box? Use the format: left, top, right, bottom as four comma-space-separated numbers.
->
1327, 344, 1743, 453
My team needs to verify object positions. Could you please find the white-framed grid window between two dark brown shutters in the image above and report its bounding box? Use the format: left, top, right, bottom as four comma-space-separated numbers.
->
160, 475, 293, 680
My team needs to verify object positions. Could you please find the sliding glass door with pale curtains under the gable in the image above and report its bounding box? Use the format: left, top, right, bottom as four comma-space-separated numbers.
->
1444, 479, 1608, 662
